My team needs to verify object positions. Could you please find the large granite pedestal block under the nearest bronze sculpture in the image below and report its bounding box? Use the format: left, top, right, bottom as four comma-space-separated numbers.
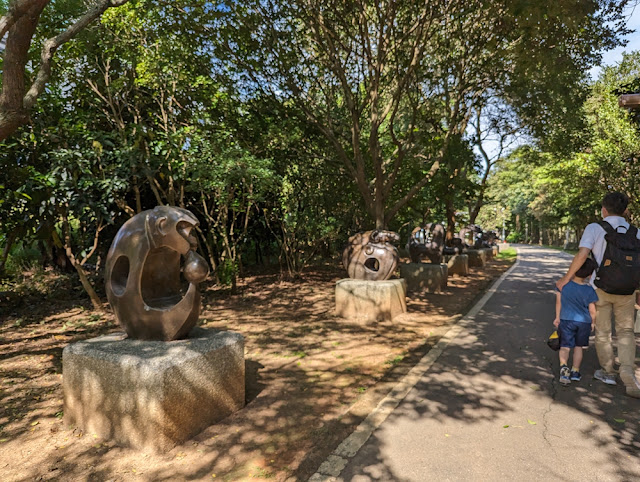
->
62, 328, 245, 452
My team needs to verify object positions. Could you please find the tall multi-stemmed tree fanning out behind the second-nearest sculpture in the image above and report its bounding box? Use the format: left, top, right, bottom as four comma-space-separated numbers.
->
215, 0, 627, 227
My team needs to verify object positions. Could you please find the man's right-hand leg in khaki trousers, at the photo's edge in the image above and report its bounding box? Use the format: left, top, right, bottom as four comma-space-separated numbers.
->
613, 295, 640, 396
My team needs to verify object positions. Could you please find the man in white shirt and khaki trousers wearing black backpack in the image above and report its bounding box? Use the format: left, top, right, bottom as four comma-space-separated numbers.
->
556, 192, 640, 398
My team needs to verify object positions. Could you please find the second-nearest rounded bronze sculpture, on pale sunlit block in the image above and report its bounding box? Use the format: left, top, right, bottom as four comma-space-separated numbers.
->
342, 229, 400, 281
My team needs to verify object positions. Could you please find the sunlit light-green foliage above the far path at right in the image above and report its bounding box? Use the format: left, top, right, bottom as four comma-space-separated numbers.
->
489, 52, 640, 240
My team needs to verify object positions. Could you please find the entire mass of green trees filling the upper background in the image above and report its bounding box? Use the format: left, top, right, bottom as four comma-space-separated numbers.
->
0, 0, 639, 305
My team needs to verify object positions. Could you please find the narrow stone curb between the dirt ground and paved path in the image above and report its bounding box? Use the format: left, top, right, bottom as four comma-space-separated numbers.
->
308, 248, 520, 482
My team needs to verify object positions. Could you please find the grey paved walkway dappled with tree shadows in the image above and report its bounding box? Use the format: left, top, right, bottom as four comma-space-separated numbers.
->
311, 246, 640, 482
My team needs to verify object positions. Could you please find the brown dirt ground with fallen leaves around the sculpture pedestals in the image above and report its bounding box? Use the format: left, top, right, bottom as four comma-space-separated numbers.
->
0, 254, 511, 481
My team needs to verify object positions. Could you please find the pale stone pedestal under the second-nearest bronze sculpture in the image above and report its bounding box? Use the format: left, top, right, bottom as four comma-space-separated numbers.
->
336, 278, 407, 323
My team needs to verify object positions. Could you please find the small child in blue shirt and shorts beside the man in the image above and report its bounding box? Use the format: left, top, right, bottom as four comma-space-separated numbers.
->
553, 258, 598, 385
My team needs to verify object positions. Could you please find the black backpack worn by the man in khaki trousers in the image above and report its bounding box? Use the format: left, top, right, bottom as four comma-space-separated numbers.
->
594, 221, 640, 295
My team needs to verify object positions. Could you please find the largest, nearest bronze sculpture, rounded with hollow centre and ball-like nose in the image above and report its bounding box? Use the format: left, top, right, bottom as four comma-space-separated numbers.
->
105, 206, 209, 341
